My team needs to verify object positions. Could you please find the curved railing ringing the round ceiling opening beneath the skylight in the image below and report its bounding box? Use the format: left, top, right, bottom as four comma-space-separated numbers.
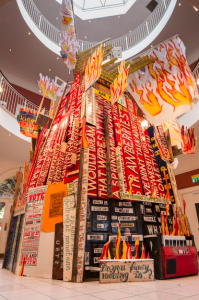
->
20, 0, 174, 52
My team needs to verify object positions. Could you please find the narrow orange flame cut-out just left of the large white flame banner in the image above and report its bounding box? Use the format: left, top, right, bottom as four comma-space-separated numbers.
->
111, 60, 130, 105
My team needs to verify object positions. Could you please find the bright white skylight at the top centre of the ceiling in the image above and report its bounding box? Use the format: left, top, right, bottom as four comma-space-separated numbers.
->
56, 0, 137, 20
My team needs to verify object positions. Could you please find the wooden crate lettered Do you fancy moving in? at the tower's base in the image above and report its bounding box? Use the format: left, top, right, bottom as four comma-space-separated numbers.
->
100, 259, 154, 283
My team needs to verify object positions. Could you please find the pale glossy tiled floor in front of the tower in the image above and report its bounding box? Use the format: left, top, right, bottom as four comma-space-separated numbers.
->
0, 262, 199, 300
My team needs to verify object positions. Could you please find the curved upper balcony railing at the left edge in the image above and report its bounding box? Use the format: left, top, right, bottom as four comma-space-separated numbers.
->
0, 71, 49, 117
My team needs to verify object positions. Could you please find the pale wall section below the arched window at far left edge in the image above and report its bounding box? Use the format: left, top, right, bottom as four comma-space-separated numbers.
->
0, 198, 13, 254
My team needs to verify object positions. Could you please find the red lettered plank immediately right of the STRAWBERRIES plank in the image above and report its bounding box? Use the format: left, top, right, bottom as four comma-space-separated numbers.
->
126, 97, 152, 196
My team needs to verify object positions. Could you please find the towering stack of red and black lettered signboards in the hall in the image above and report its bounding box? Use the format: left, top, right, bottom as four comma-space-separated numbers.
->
2, 45, 193, 282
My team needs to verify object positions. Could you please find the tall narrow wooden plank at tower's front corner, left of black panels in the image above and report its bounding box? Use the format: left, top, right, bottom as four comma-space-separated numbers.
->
77, 148, 89, 282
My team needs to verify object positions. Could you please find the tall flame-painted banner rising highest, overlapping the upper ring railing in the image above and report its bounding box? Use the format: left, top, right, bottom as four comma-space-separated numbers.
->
60, 0, 79, 69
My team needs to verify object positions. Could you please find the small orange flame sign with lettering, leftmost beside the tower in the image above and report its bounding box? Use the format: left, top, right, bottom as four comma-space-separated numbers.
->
17, 108, 39, 139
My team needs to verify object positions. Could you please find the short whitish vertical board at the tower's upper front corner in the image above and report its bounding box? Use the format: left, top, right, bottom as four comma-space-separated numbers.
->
86, 88, 96, 126
